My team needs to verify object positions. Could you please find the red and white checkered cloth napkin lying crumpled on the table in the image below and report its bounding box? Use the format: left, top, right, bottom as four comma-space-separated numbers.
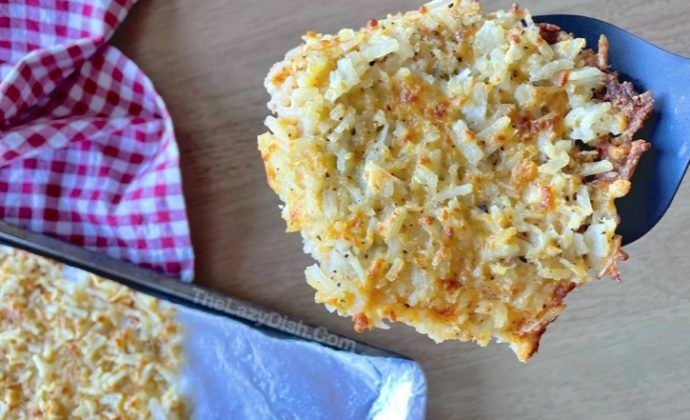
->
0, 0, 194, 281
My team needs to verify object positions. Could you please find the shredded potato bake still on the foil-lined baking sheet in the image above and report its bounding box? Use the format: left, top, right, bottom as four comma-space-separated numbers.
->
0, 250, 186, 419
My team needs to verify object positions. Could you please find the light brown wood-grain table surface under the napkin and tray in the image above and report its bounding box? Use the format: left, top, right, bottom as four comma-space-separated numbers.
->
115, 0, 690, 419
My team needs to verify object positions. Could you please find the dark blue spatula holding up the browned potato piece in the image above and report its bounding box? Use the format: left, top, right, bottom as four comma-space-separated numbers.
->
534, 15, 690, 245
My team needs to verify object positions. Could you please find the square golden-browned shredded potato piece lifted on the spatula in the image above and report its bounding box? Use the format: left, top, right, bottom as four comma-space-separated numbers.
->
259, 0, 651, 361
